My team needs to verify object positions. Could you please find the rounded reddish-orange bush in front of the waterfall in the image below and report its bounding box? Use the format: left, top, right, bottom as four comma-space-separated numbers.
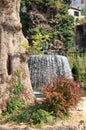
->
43, 78, 81, 117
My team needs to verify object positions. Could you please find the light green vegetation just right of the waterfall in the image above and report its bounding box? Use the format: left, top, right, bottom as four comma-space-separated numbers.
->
67, 52, 86, 87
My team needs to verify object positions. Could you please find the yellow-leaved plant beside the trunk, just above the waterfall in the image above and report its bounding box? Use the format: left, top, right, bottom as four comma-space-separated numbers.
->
22, 28, 50, 55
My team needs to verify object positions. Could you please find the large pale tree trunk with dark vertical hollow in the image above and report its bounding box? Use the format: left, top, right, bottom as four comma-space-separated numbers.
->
0, 0, 34, 111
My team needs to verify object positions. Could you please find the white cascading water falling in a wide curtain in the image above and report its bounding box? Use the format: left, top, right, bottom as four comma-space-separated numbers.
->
28, 55, 72, 89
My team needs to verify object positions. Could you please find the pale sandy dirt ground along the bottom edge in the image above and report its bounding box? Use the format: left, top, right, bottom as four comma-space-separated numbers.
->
0, 110, 86, 130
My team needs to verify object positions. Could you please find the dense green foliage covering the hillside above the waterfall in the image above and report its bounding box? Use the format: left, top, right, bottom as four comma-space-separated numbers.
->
20, 0, 74, 54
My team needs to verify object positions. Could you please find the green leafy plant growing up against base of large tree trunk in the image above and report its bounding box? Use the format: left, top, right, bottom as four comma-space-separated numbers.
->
7, 70, 24, 114
